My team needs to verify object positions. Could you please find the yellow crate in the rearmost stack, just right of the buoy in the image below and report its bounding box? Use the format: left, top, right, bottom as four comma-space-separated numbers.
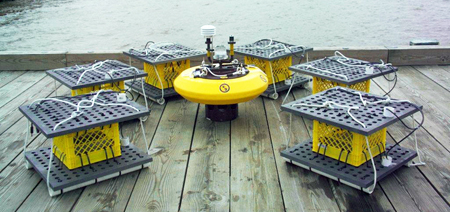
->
244, 56, 292, 85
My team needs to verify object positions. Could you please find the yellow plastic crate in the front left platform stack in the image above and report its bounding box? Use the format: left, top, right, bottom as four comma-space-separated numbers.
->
53, 123, 122, 169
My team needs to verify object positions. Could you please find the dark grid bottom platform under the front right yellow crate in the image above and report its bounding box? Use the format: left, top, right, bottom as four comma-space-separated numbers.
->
281, 139, 417, 189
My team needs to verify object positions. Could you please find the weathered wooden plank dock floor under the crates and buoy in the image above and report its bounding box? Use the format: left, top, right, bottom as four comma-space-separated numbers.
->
0, 66, 450, 212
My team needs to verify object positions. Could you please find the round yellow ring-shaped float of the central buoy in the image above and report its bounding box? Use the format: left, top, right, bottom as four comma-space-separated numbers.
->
174, 66, 268, 105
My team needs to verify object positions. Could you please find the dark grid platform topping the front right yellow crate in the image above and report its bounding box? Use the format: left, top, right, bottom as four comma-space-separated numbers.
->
281, 86, 421, 136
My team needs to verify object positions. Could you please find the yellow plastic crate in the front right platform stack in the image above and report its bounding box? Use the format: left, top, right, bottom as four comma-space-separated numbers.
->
312, 121, 386, 167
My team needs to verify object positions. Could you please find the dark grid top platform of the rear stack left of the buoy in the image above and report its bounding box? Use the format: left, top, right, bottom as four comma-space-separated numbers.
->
123, 44, 206, 65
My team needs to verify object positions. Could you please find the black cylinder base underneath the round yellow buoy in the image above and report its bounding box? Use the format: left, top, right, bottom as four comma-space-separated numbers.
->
205, 104, 238, 122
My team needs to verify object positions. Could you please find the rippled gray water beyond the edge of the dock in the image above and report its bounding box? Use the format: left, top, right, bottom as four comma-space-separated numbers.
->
0, 0, 450, 51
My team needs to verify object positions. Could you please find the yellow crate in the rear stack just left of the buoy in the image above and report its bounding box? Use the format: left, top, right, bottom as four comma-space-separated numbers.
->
144, 60, 191, 89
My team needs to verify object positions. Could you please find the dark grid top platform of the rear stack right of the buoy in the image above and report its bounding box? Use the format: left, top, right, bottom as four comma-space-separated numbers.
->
234, 39, 313, 60
